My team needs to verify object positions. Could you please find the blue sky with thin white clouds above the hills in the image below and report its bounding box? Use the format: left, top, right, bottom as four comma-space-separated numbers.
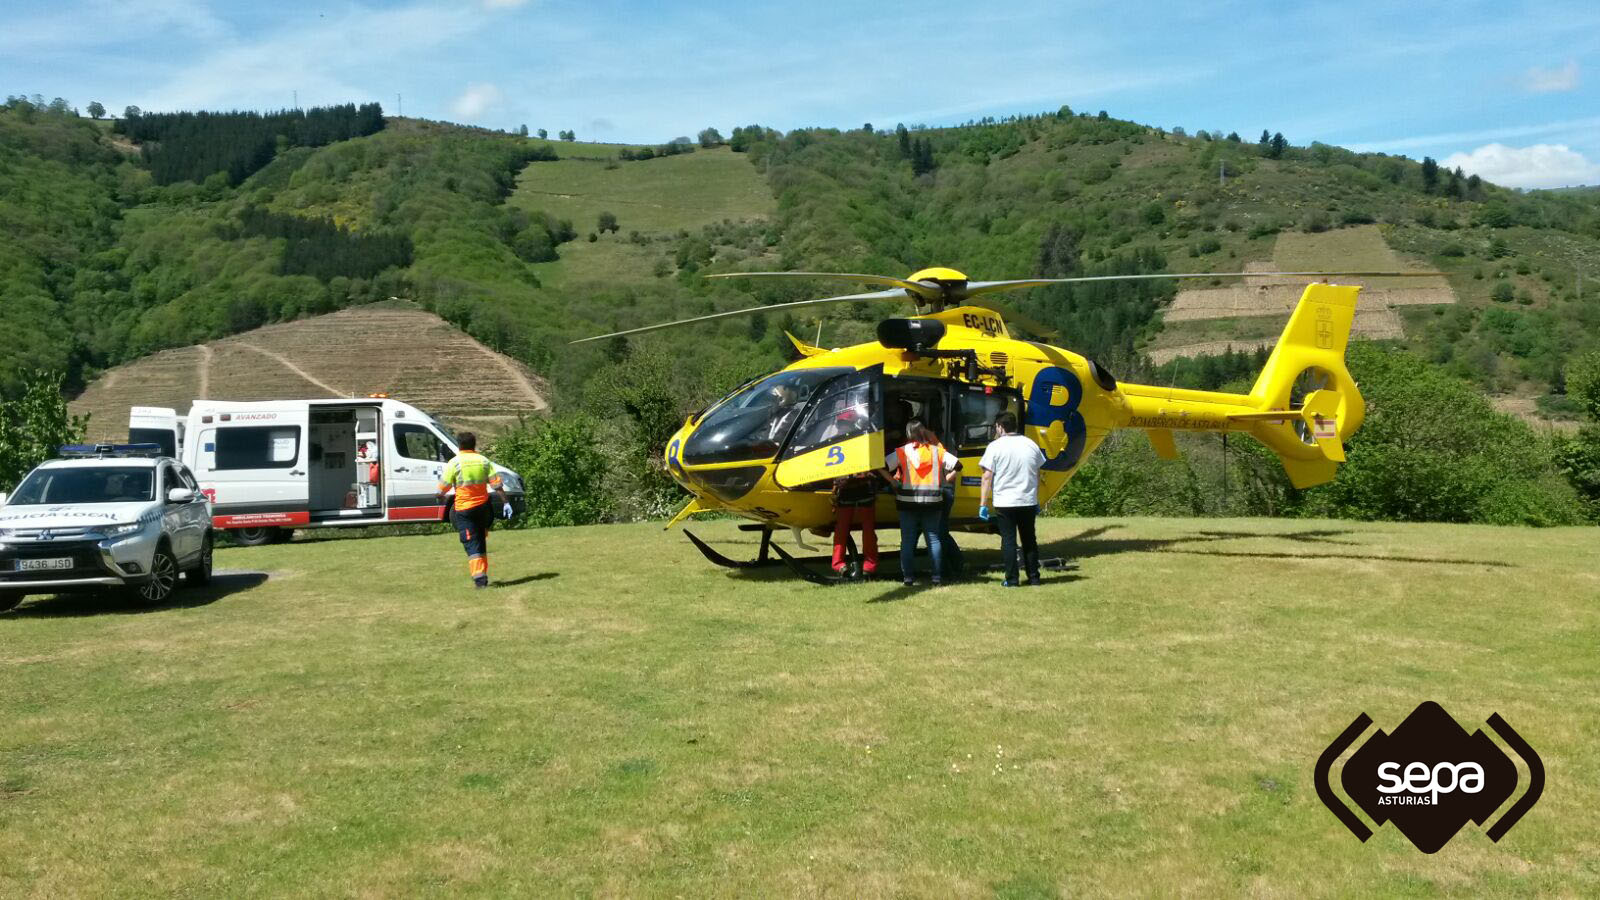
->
0, 0, 1600, 187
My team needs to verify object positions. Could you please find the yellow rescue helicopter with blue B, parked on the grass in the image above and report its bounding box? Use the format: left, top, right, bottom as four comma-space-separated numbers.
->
574, 267, 1437, 581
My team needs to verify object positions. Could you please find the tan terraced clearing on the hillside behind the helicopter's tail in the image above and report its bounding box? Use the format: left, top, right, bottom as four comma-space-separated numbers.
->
1150, 226, 1456, 364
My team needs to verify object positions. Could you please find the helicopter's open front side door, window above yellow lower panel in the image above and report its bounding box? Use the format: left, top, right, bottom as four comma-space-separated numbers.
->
773, 365, 883, 490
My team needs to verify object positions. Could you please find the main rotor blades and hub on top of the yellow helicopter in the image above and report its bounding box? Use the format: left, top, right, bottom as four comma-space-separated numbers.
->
571, 267, 1443, 344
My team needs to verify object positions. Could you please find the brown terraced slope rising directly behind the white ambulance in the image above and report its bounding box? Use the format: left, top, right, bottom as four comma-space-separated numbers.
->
72, 306, 549, 440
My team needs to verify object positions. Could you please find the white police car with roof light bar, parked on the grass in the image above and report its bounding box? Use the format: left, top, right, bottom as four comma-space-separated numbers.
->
0, 444, 213, 610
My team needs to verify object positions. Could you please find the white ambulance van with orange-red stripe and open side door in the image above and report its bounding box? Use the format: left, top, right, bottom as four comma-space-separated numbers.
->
128, 397, 523, 544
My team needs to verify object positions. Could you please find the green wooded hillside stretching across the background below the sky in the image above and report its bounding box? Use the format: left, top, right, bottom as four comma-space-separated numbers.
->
9, 98, 1600, 520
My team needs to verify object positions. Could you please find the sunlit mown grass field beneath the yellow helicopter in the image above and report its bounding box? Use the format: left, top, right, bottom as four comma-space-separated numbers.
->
0, 519, 1600, 897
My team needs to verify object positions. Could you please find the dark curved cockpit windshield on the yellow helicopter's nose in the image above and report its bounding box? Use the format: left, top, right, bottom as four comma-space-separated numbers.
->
683, 368, 853, 466
